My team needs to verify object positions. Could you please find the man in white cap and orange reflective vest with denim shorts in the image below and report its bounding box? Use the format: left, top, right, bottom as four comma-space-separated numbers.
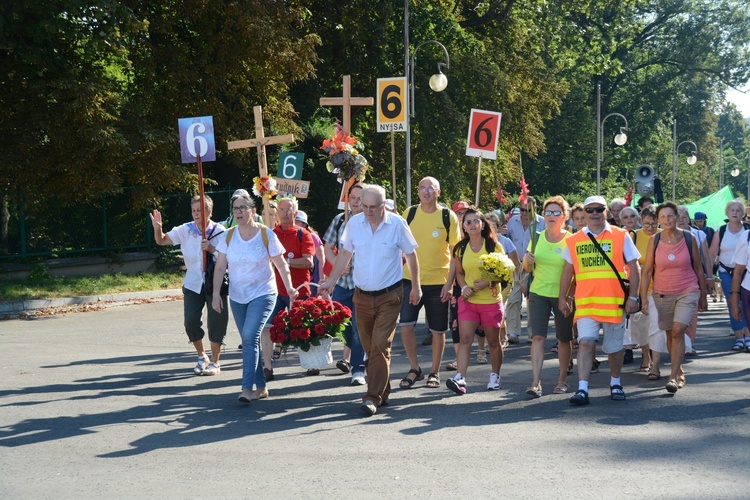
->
558, 196, 640, 405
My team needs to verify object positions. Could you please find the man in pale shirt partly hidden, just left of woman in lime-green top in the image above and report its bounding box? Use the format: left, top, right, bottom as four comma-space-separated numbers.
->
505, 196, 546, 344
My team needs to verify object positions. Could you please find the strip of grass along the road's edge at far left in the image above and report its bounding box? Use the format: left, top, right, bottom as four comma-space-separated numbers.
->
0, 272, 184, 302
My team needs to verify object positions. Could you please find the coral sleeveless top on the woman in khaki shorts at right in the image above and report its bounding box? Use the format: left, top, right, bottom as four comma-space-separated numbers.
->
654, 235, 698, 295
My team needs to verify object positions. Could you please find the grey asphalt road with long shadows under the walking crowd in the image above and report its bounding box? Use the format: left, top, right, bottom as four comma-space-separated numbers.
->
0, 301, 750, 499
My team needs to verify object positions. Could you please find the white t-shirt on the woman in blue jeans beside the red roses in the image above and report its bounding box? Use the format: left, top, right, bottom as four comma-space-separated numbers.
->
216, 228, 284, 304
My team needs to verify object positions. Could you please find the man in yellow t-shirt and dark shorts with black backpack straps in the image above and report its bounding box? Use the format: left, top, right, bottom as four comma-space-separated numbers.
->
399, 177, 461, 389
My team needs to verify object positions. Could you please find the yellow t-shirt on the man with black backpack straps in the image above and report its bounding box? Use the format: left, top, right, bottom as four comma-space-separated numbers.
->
403, 205, 461, 285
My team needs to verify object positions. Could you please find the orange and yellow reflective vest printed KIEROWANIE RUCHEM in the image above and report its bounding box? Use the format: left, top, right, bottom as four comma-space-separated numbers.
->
566, 227, 627, 323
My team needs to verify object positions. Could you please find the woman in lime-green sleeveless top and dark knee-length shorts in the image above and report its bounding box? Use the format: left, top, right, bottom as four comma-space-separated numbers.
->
523, 196, 573, 398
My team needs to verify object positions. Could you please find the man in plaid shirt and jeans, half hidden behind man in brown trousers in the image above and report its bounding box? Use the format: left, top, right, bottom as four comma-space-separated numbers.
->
323, 184, 366, 385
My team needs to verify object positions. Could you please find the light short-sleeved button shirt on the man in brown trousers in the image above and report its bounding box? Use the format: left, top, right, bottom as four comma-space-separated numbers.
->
340, 211, 418, 292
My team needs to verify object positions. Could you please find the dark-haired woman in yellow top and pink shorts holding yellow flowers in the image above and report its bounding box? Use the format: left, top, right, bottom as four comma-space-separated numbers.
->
446, 208, 504, 394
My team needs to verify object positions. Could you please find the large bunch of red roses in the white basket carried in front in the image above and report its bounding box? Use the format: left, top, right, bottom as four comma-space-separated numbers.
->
271, 297, 352, 352
